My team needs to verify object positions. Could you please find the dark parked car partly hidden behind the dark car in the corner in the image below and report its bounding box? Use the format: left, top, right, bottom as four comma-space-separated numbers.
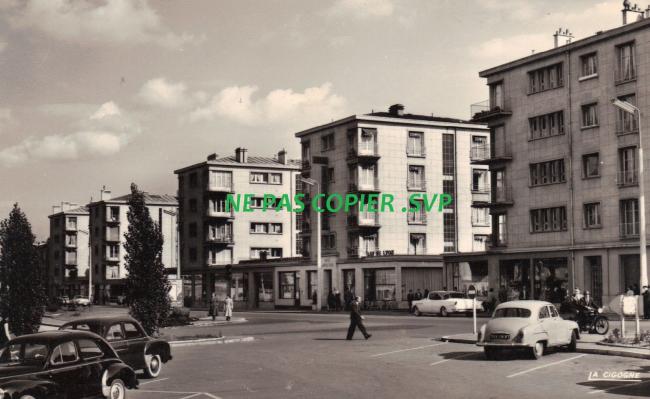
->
60, 316, 172, 378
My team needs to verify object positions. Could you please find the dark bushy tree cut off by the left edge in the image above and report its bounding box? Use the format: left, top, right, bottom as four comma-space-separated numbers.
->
0, 204, 47, 335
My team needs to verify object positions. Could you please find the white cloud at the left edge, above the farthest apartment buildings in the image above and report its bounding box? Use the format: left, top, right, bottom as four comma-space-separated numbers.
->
0, 101, 140, 167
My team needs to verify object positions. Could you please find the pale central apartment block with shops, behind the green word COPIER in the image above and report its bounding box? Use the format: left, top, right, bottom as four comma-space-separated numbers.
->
264, 104, 490, 307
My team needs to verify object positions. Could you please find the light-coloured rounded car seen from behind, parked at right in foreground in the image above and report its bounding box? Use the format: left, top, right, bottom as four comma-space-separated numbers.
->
477, 301, 580, 360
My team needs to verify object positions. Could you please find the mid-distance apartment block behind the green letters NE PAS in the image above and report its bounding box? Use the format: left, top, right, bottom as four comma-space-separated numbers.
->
174, 148, 301, 308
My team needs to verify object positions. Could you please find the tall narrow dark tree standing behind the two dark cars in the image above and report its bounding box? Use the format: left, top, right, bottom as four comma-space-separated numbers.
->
124, 183, 171, 334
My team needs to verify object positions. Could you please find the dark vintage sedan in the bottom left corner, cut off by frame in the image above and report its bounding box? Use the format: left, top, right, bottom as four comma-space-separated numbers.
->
0, 331, 138, 399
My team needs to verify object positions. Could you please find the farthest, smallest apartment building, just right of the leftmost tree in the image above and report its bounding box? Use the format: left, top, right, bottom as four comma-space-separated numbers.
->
47, 202, 90, 297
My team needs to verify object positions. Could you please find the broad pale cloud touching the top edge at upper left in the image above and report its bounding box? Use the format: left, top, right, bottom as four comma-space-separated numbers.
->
5, 0, 194, 48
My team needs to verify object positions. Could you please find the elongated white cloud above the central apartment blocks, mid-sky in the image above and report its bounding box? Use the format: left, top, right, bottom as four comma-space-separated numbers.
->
190, 83, 346, 125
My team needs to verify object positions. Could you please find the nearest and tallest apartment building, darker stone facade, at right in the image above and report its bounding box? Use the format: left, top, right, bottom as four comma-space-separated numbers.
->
446, 10, 650, 304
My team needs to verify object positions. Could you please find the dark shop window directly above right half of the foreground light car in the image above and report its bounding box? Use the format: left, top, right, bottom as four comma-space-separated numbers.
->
533, 258, 569, 303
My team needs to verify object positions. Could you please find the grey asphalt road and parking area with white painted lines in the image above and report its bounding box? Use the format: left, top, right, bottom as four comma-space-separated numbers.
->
128, 313, 650, 399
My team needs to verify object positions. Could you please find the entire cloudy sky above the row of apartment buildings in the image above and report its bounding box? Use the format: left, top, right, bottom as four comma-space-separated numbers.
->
0, 0, 622, 240
